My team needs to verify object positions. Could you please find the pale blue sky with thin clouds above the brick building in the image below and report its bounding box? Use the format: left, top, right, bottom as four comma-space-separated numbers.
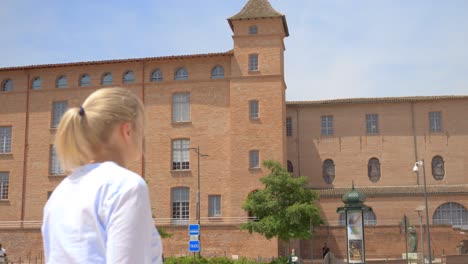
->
0, 0, 468, 100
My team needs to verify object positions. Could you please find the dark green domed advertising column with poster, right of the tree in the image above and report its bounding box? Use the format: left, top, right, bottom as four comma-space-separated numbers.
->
336, 183, 372, 264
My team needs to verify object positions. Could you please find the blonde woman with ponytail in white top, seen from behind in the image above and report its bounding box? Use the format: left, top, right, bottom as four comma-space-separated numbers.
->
42, 88, 162, 264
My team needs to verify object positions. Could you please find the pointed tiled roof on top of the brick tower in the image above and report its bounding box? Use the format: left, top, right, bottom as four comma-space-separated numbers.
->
228, 0, 289, 36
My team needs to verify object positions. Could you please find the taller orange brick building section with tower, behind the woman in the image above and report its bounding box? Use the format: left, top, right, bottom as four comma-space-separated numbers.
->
0, 0, 288, 258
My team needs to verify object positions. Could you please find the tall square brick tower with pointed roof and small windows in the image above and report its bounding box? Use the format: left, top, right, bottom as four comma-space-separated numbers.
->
228, 0, 289, 217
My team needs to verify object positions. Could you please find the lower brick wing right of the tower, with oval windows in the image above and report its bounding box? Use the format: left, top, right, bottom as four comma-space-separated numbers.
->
286, 96, 468, 258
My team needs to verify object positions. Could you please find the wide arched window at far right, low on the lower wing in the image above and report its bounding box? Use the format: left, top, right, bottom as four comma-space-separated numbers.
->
432, 202, 468, 225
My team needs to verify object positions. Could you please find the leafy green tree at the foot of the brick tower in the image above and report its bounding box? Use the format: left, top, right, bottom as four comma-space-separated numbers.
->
241, 161, 323, 241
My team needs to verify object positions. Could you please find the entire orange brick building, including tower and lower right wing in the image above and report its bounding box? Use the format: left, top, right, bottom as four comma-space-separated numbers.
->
0, 0, 468, 258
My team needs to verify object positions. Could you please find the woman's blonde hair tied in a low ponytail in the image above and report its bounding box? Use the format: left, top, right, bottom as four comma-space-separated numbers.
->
54, 88, 144, 170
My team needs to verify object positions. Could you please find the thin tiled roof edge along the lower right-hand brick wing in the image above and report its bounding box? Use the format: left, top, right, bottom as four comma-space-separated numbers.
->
286, 95, 468, 106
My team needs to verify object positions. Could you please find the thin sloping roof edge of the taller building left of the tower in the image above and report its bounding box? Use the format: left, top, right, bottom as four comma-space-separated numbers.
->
0, 50, 234, 71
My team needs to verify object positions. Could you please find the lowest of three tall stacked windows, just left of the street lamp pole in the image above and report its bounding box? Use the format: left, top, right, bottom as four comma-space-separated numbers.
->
171, 187, 190, 225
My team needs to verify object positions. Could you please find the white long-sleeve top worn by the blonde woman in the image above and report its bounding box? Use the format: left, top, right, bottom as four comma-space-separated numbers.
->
42, 162, 162, 264
